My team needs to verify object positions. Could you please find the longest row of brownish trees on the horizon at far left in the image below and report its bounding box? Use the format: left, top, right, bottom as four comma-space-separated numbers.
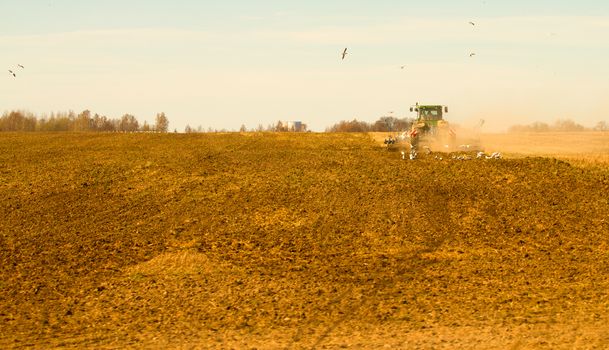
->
0, 110, 169, 132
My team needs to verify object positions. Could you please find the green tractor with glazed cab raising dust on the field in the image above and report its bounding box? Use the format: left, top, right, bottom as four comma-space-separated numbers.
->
408, 103, 456, 159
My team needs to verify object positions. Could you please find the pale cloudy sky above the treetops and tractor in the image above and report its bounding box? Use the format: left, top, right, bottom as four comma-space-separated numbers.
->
0, 0, 609, 131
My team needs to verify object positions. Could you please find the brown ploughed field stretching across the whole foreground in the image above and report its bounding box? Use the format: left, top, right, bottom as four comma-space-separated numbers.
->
0, 133, 609, 349
